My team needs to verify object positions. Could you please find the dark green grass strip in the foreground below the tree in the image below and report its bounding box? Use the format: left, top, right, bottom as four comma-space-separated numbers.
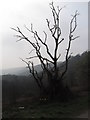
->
3, 96, 88, 118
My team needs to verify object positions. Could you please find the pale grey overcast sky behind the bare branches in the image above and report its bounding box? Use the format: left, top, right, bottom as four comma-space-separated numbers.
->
0, 0, 88, 69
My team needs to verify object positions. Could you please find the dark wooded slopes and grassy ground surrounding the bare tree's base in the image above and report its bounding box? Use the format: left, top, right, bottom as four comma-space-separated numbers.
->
2, 52, 90, 118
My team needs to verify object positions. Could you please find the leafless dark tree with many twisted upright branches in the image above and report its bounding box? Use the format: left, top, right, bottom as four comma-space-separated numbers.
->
12, 2, 79, 98
